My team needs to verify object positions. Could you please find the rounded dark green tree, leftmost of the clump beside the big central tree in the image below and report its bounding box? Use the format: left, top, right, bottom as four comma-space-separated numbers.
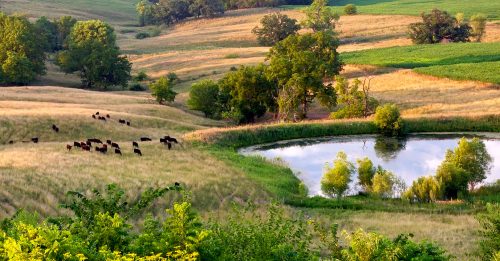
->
187, 80, 220, 118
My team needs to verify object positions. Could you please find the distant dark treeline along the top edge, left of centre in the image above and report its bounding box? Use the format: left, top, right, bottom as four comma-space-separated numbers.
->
136, 0, 312, 26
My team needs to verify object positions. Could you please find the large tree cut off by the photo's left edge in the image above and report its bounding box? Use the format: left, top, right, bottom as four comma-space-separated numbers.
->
0, 12, 46, 85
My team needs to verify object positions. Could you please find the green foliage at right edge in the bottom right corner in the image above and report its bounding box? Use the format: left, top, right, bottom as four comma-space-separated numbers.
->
477, 204, 500, 260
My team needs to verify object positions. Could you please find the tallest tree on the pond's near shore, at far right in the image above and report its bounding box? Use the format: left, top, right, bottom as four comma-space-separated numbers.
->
445, 138, 493, 188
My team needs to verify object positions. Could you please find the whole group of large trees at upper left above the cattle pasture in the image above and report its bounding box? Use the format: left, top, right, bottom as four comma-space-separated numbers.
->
0, 13, 131, 88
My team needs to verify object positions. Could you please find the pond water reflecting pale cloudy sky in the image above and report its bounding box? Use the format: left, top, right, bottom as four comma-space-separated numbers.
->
240, 134, 500, 196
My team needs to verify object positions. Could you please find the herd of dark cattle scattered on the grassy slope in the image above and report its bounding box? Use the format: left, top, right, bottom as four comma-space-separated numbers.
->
9, 112, 179, 156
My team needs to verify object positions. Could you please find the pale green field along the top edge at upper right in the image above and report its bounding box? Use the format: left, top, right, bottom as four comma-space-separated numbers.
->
288, 0, 500, 20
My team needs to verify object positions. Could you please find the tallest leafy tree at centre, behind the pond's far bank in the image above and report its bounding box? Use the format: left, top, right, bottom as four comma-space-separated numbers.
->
267, 31, 342, 119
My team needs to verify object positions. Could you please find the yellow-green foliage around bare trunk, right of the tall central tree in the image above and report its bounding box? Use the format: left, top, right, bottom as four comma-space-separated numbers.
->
330, 77, 378, 119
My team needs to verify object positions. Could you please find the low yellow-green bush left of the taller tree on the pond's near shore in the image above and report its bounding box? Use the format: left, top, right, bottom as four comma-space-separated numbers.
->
403, 176, 441, 203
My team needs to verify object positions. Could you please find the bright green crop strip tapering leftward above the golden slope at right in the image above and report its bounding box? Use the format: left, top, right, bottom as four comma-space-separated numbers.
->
342, 43, 500, 84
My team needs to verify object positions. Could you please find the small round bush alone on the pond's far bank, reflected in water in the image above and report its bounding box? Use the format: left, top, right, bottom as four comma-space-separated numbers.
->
374, 104, 403, 136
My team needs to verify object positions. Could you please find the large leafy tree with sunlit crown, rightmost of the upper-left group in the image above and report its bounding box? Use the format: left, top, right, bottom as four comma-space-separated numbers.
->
57, 20, 131, 88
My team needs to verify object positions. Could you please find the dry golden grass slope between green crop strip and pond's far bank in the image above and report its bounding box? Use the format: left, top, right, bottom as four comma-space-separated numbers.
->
344, 66, 500, 116
